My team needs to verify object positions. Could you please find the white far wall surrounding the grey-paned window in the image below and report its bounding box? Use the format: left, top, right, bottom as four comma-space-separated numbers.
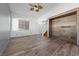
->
11, 14, 41, 37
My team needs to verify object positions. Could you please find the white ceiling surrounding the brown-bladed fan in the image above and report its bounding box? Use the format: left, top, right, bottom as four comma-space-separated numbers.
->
9, 3, 58, 19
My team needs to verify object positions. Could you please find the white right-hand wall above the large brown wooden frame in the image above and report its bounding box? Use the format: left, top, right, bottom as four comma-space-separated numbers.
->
39, 3, 79, 36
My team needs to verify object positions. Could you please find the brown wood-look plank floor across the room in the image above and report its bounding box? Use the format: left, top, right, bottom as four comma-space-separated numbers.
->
3, 35, 79, 56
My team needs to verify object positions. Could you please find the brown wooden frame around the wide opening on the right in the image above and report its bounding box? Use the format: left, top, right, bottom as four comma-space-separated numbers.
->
48, 7, 79, 45
